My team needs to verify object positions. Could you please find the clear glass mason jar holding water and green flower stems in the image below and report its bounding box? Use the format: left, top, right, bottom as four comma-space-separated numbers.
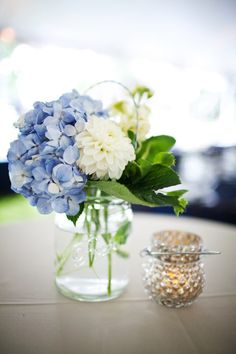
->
55, 190, 133, 301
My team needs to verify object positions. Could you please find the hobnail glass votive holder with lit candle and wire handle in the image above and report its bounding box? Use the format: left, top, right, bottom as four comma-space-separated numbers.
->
143, 230, 205, 308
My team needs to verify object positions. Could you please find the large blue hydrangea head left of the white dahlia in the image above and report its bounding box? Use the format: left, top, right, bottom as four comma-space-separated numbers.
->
8, 90, 107, 215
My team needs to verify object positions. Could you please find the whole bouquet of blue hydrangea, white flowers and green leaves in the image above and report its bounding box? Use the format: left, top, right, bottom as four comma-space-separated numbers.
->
8, 83, 186, 223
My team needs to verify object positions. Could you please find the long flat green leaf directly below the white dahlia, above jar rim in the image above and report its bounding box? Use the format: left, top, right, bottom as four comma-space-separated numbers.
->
88, 181, 155, 206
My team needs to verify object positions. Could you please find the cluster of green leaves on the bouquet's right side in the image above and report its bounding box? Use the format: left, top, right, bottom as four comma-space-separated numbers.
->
86, 131, 187, 215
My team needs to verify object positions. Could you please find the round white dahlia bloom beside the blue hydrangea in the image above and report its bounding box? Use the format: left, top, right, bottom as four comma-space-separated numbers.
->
76, 117, 135, 179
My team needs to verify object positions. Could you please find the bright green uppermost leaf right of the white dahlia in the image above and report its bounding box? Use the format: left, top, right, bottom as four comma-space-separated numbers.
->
136, 135, 175, 163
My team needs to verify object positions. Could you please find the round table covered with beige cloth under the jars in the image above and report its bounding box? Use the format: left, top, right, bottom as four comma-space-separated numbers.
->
0, 213, 236, 354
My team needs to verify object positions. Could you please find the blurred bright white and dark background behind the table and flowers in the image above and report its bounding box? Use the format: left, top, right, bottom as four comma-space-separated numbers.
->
0, 0, 236, 224
